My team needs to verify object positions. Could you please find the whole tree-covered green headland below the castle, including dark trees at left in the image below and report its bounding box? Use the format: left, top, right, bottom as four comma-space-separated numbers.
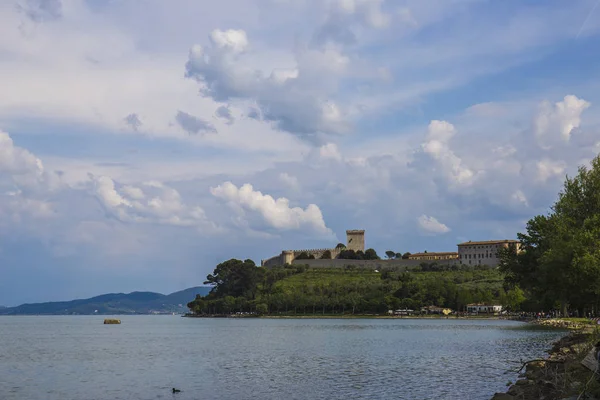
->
188, 260, 523, 314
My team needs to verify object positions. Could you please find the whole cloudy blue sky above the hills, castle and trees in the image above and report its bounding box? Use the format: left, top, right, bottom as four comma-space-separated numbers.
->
0, 0, 600, 306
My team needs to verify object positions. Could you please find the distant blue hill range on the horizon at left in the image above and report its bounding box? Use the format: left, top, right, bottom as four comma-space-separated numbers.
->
0, 286, 211, 315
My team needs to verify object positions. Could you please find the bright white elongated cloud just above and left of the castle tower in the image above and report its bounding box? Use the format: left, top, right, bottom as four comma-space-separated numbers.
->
210, 182, 331, 234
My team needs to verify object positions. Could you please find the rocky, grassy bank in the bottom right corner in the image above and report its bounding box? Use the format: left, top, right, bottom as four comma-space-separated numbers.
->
492, 320, 600, 400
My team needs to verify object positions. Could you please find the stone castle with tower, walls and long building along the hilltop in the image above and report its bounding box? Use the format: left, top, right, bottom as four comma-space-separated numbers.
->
261, 229, 521, 267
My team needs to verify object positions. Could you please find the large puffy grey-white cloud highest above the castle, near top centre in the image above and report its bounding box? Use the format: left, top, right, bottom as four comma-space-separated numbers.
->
186, 29, 349, 136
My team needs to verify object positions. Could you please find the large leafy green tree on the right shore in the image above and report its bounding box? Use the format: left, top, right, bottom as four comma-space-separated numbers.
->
500, 156, 600, 313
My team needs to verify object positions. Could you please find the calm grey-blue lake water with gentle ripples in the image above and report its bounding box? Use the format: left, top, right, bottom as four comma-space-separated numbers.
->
0, 316, 564, 400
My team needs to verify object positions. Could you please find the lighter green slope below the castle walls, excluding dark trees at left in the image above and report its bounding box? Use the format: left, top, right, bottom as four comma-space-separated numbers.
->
266, 268, 504, 313
